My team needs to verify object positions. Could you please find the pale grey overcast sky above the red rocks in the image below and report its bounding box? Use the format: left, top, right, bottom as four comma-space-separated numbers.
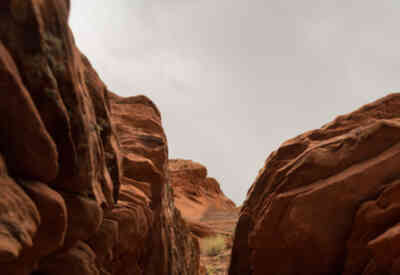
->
70, 0, 400, 204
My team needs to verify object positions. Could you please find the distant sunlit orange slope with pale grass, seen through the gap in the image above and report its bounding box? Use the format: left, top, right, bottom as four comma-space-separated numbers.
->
168, 159, 239, 275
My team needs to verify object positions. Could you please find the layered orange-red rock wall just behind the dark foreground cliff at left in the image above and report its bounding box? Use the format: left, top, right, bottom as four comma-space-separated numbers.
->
111, 95, 199, 275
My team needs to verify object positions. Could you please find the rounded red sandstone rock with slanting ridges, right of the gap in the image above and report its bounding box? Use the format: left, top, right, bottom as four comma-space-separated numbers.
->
229, 94, 400, 275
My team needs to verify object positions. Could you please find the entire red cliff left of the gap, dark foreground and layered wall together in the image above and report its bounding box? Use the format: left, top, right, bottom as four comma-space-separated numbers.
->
0, 0, 199, 275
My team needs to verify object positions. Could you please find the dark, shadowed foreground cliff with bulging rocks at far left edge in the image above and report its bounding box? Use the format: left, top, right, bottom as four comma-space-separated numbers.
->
0, 0, 119, 275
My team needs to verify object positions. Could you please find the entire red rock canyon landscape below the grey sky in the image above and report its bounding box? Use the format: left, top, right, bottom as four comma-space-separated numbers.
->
0, 0, 400, 275
